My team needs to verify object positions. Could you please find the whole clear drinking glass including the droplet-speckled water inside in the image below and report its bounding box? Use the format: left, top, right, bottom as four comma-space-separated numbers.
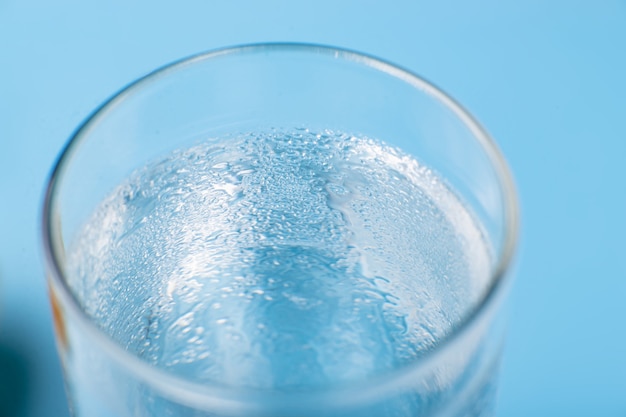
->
43, 44, 518, 417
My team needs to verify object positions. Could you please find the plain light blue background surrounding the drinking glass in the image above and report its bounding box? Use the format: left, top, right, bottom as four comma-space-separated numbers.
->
0, 0, 626, 417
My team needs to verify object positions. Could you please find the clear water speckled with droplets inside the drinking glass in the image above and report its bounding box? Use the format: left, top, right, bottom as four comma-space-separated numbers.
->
67, 130, 491, 389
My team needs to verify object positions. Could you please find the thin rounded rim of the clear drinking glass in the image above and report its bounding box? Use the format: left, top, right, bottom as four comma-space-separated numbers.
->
41, 43, 519, 411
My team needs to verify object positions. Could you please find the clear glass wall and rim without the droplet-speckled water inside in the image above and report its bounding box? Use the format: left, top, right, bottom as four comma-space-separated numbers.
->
43, 44, 518, 417
